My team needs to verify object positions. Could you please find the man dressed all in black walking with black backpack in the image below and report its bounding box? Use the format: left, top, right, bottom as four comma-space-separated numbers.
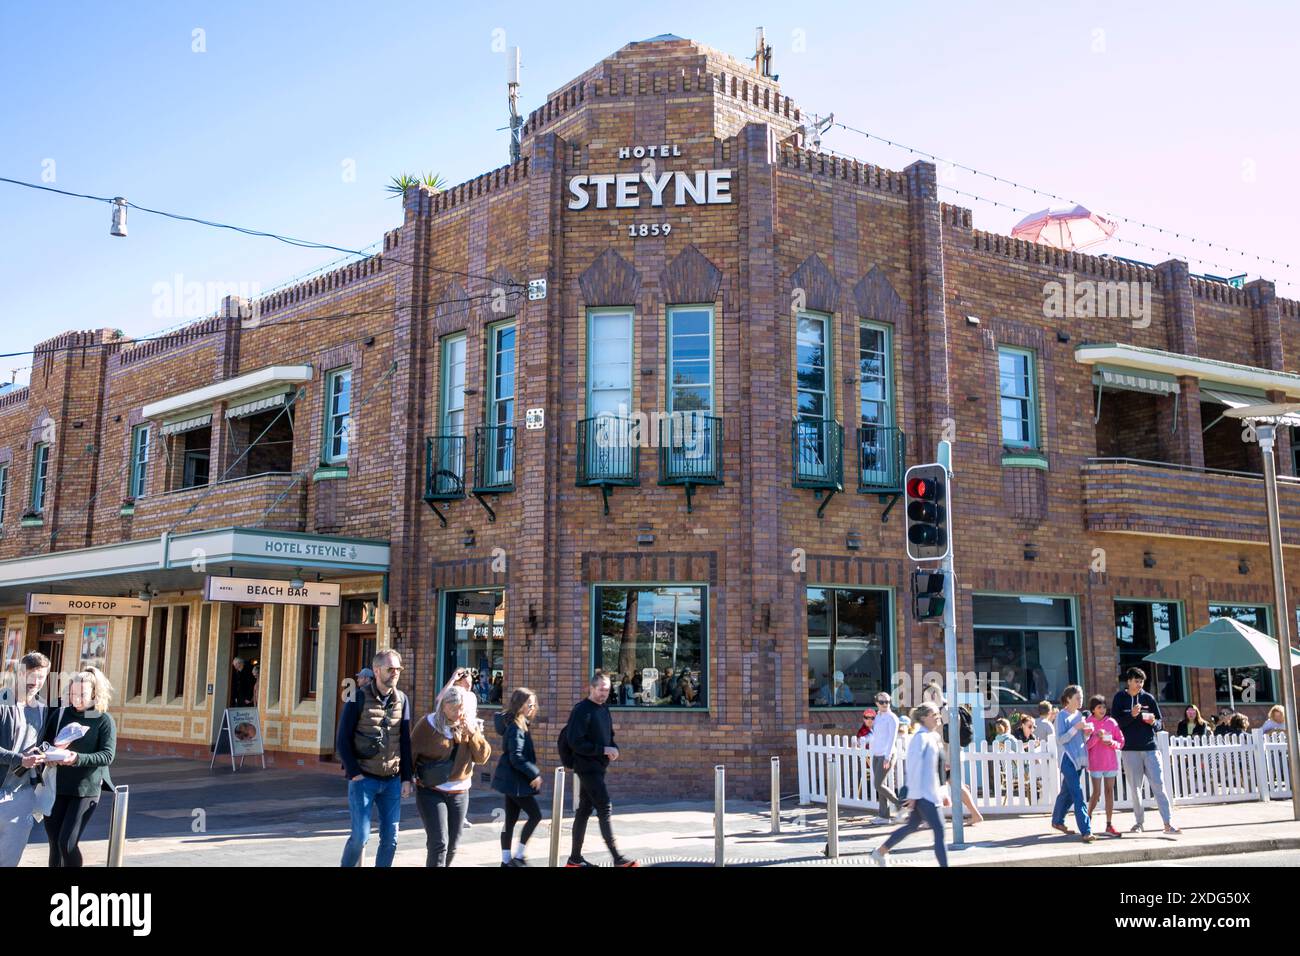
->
564, 671, 637, 868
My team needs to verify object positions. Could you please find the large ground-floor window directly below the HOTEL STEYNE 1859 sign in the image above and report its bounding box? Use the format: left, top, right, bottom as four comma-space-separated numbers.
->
593, 585, 709, 708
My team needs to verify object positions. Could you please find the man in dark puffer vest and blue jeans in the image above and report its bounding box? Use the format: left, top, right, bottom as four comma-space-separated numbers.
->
334, 649, 413, 866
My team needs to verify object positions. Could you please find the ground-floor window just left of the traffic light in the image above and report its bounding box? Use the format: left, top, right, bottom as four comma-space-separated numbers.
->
807, 588, 893, 708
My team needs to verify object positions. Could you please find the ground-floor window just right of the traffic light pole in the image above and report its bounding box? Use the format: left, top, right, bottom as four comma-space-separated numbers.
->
972, 594, 1079, 708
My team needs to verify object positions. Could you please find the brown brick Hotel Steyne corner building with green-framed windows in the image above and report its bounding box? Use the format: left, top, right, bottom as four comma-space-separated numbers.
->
0, 36, 1300, 795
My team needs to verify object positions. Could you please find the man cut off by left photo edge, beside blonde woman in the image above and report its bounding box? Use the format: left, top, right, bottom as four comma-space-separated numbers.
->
0, 652, 49, 866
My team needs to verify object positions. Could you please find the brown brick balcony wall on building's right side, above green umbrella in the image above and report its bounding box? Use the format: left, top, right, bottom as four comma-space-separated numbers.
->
1083, 458, 1300, 545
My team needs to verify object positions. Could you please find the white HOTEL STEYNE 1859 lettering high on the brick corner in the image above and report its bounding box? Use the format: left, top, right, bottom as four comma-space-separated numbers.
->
568, 144, 732, 238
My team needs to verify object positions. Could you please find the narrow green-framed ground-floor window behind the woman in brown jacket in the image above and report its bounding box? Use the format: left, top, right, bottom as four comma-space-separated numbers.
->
438, 589, 507, 706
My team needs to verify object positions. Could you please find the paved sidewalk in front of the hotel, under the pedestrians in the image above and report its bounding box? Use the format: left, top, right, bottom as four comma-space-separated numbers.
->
12, 757, 1300, 866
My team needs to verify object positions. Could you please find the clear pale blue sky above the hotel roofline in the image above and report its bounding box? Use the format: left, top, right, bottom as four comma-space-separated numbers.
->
0, 0, 1300, 382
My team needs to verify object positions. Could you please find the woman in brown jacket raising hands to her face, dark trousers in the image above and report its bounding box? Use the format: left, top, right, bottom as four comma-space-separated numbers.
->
411, 685, 491, 866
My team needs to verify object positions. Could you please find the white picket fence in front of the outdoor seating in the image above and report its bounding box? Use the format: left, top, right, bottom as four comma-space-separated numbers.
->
796, 730, 1291, 814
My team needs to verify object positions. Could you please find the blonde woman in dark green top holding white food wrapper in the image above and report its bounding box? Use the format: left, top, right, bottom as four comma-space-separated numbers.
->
42, 667, 117, 866
